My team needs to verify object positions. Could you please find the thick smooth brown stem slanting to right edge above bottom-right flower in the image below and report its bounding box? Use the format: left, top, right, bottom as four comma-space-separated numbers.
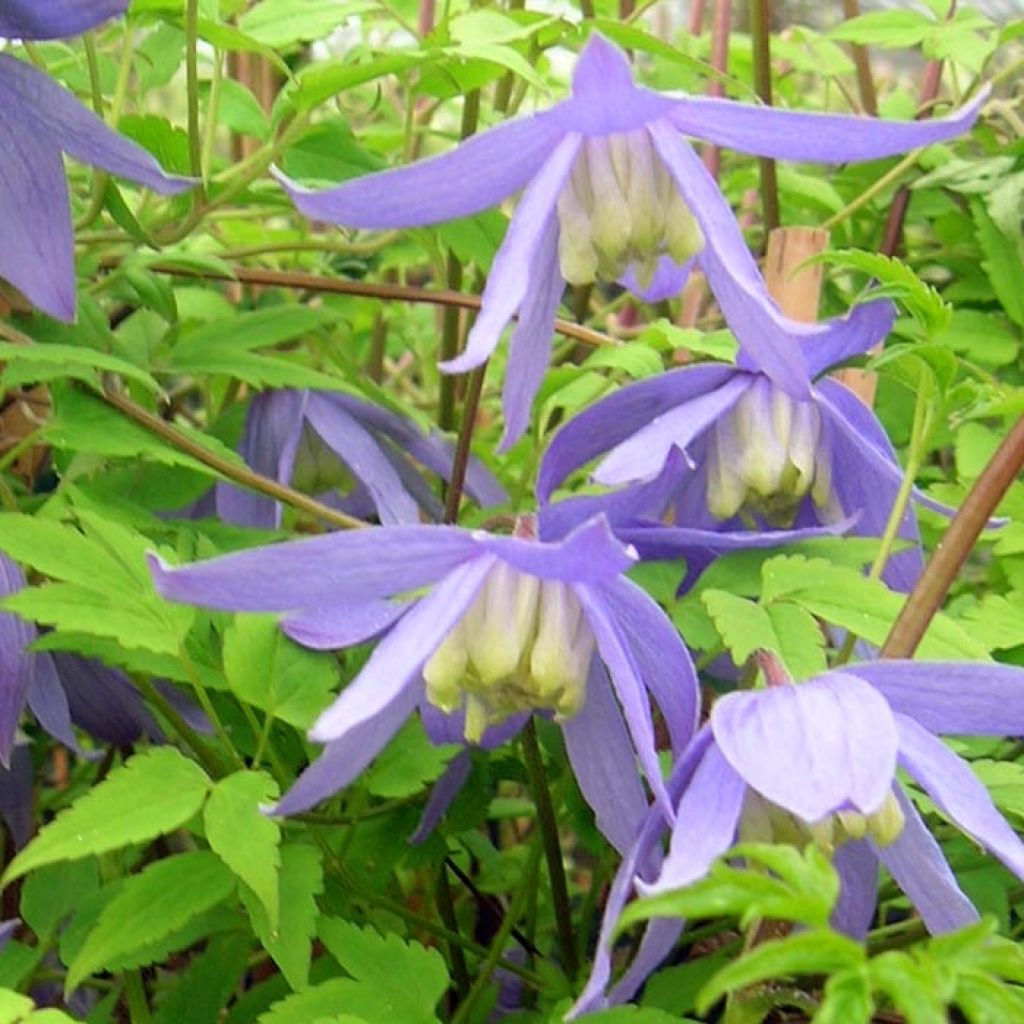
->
881, 416, 1024, 657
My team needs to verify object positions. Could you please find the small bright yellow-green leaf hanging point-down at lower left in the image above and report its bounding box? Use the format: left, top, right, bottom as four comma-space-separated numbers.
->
203, 771, 281, 932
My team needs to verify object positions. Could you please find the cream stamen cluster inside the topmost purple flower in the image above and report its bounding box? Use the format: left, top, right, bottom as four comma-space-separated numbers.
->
558, 128, 705, 287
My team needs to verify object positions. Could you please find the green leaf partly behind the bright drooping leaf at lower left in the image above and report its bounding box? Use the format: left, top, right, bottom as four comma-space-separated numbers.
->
239, 844, 324, 990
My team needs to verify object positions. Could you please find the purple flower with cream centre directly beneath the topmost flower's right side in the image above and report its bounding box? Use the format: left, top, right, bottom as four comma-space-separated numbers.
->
538, 301, 948, 590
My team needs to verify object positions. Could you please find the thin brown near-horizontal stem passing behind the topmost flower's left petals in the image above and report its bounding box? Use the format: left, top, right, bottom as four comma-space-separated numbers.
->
119, 259, 618, 347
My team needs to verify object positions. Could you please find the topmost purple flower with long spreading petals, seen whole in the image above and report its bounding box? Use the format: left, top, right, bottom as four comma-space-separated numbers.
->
279, 33, 983, 445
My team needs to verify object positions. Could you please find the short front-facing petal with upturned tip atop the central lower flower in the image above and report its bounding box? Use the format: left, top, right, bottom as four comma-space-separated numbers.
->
473, 516, 637, 584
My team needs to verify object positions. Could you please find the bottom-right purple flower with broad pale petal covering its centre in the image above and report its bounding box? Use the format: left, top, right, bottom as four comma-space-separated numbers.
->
574, 660, 1024, 1013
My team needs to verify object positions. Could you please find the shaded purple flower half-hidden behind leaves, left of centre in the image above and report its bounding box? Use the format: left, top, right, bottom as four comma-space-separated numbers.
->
216, 390, 507, 527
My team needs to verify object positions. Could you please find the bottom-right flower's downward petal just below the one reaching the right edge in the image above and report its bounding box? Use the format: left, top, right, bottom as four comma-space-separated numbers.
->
873, 786, 980, 935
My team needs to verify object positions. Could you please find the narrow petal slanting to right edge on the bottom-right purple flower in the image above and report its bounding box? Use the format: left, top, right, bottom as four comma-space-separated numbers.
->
896, 715, 1024, 878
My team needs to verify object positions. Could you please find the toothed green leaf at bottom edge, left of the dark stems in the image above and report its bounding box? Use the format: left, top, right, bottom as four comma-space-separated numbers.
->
319, 918, 449, 1024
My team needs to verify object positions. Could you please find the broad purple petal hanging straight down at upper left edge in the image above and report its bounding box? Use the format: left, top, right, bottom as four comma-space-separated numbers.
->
0, 95, 75, 322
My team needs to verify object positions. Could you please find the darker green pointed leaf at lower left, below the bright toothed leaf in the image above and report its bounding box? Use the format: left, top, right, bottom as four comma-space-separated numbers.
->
65, 850, 234, 991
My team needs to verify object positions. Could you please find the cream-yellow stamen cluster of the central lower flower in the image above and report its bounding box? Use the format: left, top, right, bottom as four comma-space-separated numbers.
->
423, 562, 595, 742
